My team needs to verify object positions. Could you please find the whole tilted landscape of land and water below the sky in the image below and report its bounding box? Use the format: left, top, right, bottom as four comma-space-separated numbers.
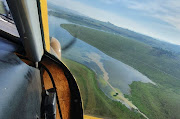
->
48, 3, 180, 119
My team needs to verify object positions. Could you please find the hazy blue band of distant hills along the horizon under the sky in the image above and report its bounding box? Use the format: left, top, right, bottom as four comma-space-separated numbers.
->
48, 3, 180, 54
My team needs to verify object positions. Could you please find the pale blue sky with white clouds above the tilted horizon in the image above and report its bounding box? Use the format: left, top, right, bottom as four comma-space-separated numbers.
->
50, 0, 180, 45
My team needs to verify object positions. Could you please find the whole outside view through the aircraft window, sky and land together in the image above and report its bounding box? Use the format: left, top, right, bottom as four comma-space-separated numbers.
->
48, 0, 180, 119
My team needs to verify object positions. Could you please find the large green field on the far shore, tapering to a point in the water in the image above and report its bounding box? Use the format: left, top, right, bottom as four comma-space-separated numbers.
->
61, 24, 180, 119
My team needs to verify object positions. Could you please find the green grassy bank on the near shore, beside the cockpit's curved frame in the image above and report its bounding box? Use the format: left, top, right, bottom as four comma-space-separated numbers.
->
63, 59, 143, 119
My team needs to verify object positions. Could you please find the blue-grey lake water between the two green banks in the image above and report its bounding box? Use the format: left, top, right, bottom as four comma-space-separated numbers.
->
49, 16, 155, 95
